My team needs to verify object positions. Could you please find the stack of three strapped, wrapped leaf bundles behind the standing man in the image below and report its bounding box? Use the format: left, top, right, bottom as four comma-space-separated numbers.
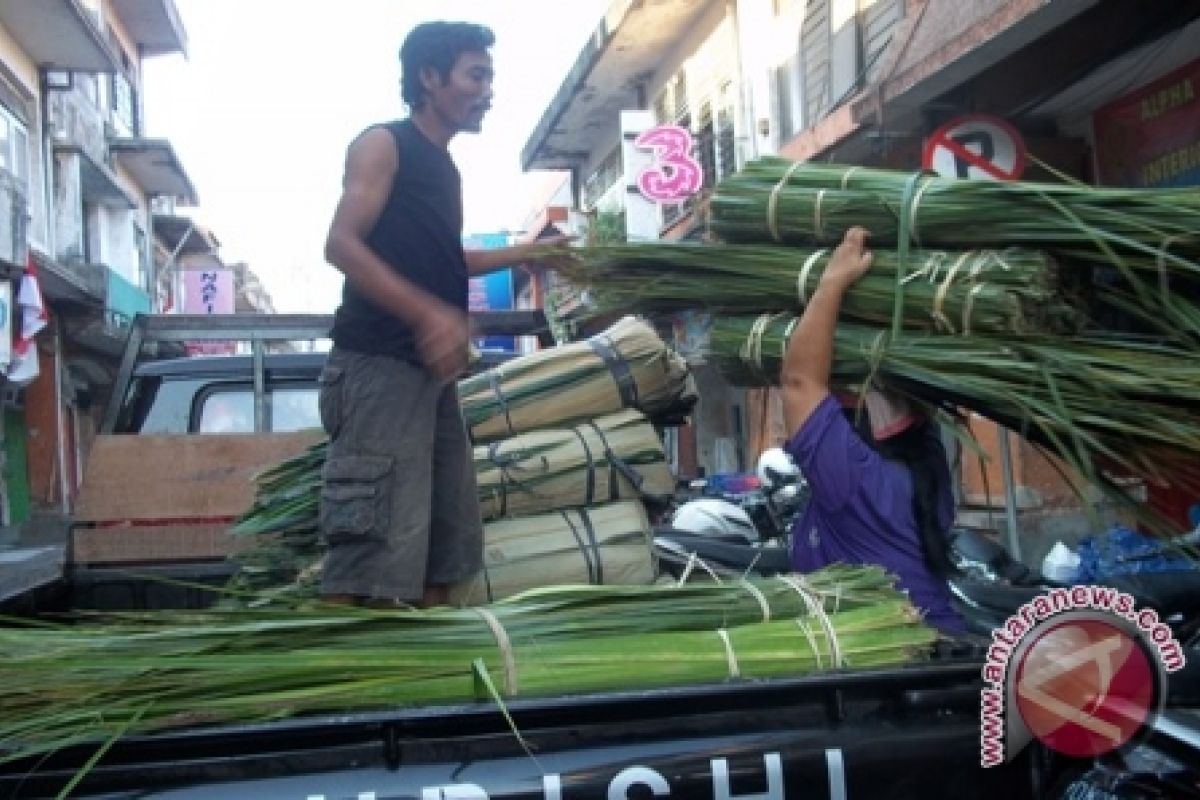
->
230, 318, 694, 603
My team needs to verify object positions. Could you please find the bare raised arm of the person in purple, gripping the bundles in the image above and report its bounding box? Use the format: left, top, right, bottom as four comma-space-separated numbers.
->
779, 227, 872, 434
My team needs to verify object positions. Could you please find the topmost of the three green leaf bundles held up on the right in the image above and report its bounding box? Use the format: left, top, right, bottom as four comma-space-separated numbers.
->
712, 157, 1200, 275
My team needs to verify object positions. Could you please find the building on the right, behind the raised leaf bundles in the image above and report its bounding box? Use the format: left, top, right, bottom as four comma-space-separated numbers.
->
522, 0, 1200, 557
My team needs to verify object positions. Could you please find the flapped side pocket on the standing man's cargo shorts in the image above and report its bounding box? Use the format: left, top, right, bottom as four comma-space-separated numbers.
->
320, 456, 392, 545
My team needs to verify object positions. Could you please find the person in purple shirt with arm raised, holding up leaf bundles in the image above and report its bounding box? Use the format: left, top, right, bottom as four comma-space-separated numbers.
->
780, 227, 965, 634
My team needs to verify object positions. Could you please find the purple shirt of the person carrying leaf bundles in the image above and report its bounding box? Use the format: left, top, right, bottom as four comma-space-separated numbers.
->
785, 395, 964, 633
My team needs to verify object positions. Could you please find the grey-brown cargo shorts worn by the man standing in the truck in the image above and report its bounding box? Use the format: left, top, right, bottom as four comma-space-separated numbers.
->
319, 348, 484, 602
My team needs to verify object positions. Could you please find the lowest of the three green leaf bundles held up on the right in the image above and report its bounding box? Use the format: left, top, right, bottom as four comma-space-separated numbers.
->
709, 314, 1200, 513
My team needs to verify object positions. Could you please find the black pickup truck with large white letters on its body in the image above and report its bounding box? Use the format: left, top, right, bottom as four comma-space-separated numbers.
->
0, 316, 1200, 800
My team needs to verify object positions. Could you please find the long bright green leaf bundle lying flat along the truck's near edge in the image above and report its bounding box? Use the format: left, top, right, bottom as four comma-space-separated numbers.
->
0, 567, 936, 762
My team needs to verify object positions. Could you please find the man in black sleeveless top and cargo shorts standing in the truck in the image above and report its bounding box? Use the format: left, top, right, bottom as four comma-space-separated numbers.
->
320, 22, 566, 606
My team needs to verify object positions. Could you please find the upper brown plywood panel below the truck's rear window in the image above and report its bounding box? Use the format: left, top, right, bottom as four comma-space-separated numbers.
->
74, 431, 324, 523
